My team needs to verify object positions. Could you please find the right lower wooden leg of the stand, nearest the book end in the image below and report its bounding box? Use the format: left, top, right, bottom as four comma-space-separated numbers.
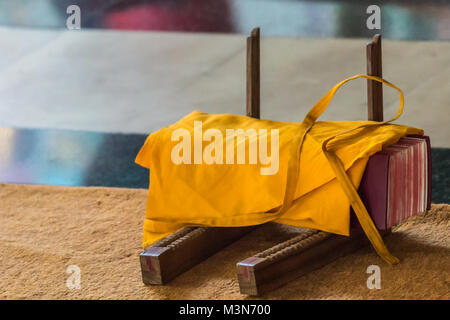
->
237, 230, 387, 296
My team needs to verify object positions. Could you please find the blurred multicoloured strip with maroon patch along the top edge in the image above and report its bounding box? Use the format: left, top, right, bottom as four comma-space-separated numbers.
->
0, 0, 450, 40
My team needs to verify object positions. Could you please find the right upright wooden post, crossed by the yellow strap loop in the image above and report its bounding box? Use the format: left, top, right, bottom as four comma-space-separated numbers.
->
367, 34, 383, 121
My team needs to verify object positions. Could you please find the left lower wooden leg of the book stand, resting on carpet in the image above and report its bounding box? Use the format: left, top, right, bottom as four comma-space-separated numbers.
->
140, 227, 253, 285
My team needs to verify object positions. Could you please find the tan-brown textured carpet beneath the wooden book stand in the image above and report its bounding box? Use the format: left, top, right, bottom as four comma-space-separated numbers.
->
0, 184, 450, 299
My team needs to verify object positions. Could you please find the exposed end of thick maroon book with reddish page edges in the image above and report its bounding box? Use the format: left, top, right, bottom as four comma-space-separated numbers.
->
353, 136, 431, 230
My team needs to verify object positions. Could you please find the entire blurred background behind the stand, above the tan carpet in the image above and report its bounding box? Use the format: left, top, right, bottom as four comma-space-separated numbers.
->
0, 0, 450, 202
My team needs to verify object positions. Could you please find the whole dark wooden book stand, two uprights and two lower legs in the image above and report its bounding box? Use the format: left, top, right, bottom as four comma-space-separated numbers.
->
140, 28, 383, 295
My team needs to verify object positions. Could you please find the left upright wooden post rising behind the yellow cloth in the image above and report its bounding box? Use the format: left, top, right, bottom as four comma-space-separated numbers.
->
247, 28, 260, 119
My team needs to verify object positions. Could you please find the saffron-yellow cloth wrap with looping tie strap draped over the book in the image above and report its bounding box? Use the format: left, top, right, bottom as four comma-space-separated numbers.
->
136, 75, 423, 264
